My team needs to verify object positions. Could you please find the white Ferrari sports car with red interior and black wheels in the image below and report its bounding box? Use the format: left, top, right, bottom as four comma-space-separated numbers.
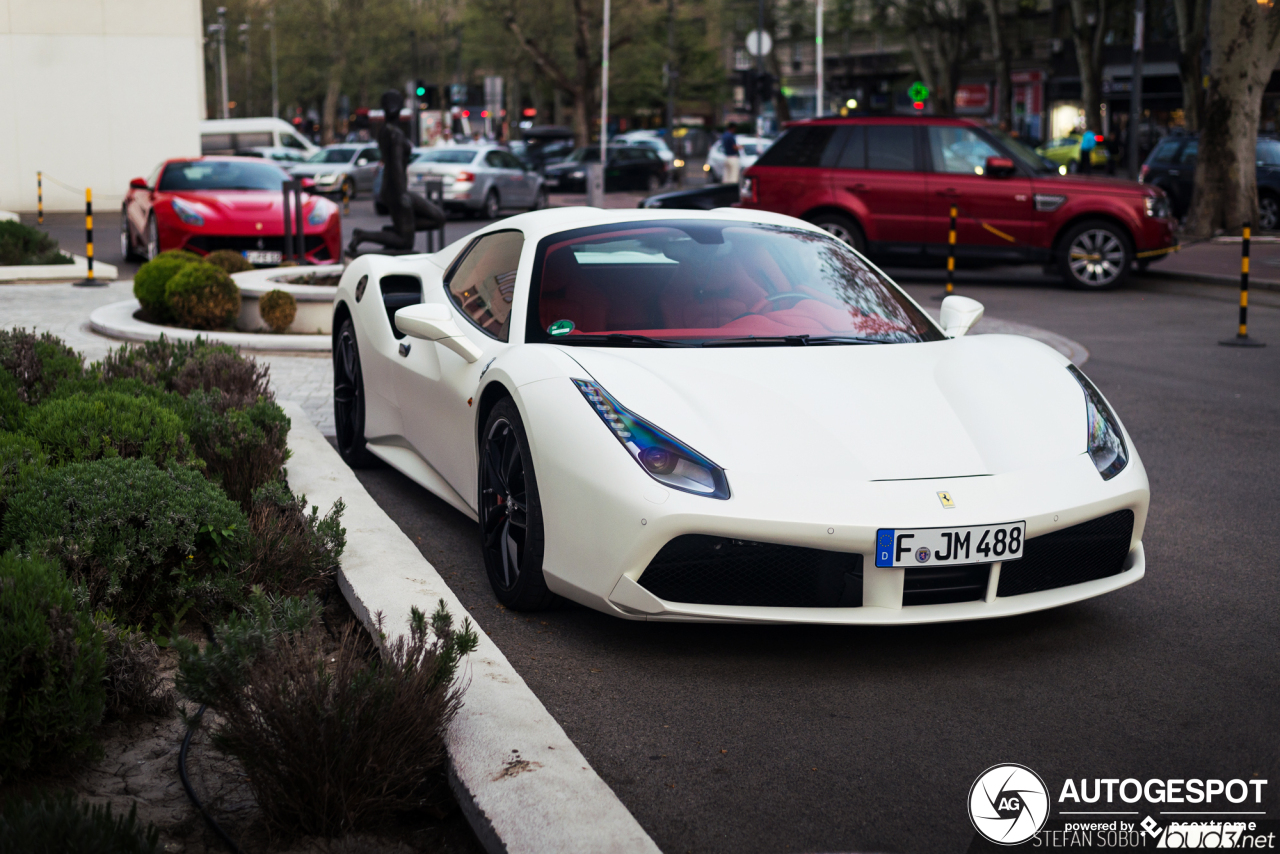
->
333, 207, 1149, 624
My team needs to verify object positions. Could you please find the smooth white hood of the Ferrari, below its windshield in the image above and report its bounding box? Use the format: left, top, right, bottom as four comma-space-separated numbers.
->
561, 335, 1085, 489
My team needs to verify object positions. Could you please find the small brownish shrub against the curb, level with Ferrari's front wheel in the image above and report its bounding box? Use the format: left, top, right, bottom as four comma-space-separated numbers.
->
242, 480, 347, 594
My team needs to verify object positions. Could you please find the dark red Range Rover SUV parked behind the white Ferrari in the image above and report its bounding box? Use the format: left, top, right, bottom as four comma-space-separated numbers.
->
740, 117, 1176, 288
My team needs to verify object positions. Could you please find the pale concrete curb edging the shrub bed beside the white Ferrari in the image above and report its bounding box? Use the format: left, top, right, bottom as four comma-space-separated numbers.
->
282, 402, 658, 854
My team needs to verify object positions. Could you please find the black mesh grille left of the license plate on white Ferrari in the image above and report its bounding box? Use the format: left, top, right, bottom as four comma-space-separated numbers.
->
640, 534, 863, 608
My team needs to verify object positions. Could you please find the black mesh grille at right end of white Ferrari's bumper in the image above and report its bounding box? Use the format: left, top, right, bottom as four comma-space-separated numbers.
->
996, 510, 1133, 597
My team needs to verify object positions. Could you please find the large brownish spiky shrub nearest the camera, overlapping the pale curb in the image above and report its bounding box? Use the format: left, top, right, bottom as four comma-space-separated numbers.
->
178, 594, 476, 836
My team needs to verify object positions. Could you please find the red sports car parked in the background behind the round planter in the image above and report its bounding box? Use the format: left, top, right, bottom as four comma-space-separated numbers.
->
120, 157, 342, 266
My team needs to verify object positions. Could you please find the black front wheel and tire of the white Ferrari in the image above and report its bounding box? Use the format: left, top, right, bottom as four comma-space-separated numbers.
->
476, 397, 558, 611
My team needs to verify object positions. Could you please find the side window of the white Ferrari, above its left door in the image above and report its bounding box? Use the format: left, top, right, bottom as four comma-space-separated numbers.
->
444, 232, 525, 341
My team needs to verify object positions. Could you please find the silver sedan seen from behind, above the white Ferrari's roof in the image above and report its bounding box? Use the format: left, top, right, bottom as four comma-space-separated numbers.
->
408, 145, 547, 219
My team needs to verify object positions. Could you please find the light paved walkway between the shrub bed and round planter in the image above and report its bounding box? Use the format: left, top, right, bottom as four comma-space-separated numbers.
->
0, 280, 334, 435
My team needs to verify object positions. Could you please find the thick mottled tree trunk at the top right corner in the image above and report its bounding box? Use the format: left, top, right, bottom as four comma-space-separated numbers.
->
1187, 0, 1280, 239
